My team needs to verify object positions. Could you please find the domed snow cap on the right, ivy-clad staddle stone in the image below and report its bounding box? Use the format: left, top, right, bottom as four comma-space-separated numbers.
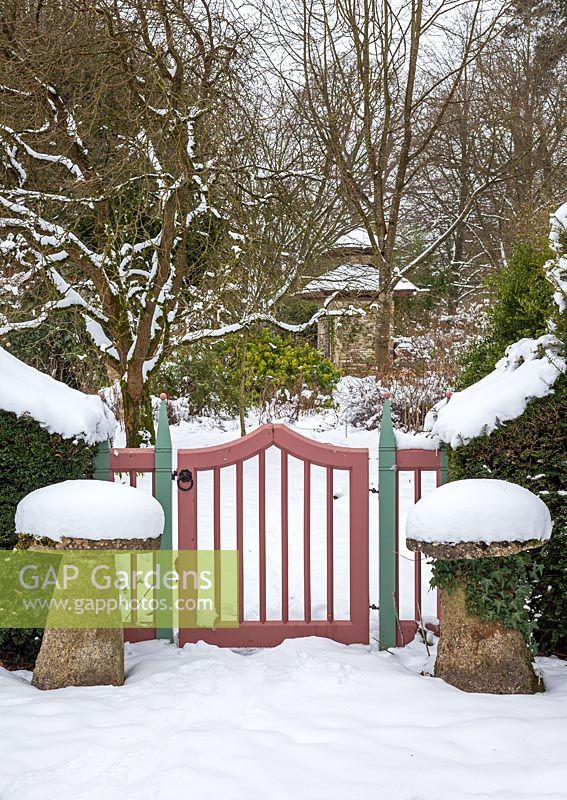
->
406, 478, 551, 544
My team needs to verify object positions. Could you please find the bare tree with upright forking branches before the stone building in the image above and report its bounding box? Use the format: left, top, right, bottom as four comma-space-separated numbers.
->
271, 0, 510, 368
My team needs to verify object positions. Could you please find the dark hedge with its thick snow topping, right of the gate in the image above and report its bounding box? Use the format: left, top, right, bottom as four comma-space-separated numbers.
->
442, 214, 567, 653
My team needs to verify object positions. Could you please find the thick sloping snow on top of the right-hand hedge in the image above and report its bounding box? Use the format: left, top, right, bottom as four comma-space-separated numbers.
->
425, 334, 566, 447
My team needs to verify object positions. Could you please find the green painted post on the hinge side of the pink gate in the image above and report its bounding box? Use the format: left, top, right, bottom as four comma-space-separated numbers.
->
378, 394, 397, 650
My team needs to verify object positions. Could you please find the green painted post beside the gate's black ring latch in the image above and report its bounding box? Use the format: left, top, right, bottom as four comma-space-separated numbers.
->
154, 394, 173, 642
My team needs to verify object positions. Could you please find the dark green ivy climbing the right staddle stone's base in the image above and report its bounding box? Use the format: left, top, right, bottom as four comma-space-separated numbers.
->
431, 552, 541, 649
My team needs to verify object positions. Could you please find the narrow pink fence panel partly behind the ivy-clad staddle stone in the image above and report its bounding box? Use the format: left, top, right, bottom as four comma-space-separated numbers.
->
395, 449, 445, 647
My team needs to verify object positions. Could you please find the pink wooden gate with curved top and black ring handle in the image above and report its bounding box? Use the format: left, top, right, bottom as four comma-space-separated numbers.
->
177, 425, 369, 647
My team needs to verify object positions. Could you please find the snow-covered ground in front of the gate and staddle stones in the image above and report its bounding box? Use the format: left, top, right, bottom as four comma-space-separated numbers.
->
0, 638, 567, 800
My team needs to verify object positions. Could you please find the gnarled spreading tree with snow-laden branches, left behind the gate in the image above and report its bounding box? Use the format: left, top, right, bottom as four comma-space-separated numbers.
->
0, 0, 356, 446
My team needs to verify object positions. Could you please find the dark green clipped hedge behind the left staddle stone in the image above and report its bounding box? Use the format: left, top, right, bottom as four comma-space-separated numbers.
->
0, 411, 95, 666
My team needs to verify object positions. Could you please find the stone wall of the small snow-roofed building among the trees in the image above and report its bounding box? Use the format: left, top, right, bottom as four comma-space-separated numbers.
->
317, 299, 377, 375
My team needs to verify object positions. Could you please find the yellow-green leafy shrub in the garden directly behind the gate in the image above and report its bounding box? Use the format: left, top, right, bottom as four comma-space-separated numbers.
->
152, 329, 339, 415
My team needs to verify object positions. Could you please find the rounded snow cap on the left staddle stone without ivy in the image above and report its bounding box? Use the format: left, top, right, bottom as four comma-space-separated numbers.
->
16, 480, 164, 542
